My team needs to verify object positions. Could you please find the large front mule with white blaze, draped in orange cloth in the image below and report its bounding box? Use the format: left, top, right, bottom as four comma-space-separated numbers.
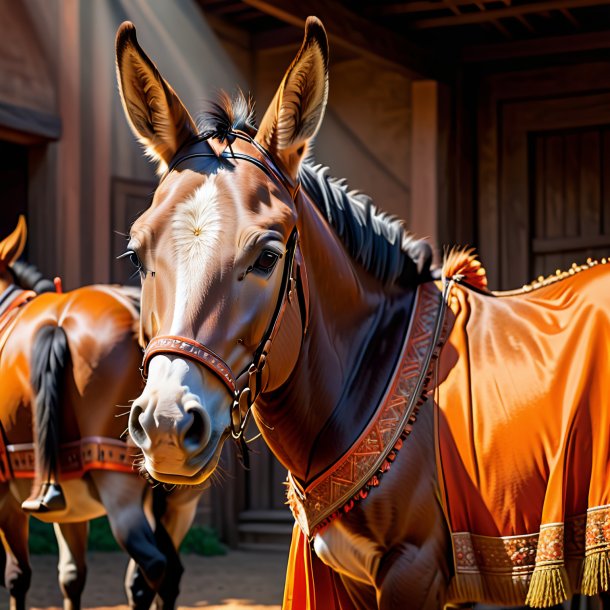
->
116, 18, 610, 609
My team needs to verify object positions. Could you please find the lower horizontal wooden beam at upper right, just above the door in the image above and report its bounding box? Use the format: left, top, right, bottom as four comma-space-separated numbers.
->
461, 30, 610, 63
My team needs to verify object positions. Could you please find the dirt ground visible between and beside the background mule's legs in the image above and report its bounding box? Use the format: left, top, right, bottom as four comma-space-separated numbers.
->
0, 551, 287, 610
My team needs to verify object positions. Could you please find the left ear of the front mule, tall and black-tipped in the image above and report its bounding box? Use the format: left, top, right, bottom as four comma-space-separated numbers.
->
116, 21, 197, 173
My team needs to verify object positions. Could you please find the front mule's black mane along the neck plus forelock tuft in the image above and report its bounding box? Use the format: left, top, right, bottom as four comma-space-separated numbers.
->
198, 91, 432, 287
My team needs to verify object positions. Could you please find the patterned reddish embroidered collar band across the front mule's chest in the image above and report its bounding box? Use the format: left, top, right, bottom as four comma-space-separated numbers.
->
288, 283, 443, 536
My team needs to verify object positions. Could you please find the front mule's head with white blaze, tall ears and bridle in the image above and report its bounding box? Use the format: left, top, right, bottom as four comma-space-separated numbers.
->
116, 18, 328, 484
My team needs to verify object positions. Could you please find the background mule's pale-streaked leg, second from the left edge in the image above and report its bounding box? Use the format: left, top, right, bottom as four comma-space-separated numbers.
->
53, 521, 89, 610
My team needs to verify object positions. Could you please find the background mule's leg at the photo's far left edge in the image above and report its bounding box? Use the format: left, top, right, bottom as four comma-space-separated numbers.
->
0, 484, 32, 610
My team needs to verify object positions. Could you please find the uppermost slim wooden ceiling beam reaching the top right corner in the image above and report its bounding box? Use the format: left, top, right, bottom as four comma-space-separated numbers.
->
411, 0, 608, 30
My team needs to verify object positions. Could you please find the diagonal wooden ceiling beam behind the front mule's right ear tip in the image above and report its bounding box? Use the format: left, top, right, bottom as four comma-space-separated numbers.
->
242, 0, 451, 80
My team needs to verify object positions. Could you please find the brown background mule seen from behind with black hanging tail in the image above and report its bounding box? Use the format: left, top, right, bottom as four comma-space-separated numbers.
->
0, 218, 200, 610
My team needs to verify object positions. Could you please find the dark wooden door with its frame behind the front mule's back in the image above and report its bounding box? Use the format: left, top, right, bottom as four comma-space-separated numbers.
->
478, 62, 610, 289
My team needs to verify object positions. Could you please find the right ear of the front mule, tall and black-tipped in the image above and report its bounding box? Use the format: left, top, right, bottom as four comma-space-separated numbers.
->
256, 17, 328, 177
